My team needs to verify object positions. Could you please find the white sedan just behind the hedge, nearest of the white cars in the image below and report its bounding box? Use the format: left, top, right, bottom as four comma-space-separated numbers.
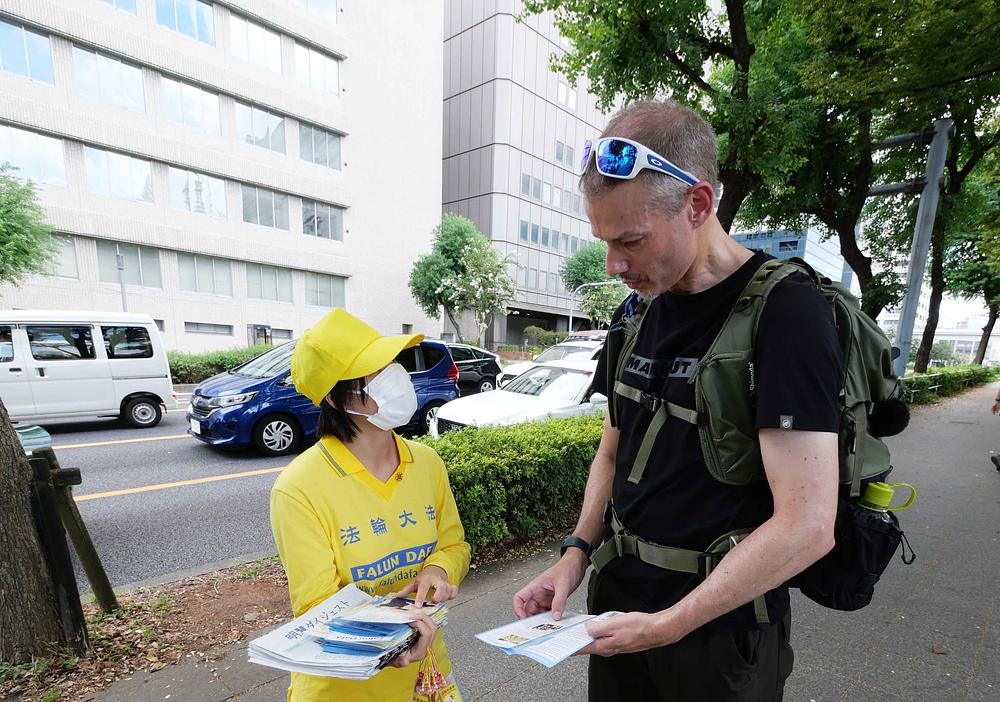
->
431, 361, 608, 437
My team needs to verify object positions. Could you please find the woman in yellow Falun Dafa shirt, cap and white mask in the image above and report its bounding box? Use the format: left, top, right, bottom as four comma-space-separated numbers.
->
271, 309, 470, 702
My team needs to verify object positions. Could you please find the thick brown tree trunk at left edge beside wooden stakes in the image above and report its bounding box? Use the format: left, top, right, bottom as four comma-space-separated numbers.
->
0, 401, 66, 664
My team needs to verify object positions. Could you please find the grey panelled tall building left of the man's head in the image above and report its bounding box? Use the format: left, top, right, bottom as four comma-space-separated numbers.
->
442, 0, 607, 344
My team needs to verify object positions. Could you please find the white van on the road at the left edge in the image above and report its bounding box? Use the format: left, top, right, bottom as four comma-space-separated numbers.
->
0, 310, 176, 427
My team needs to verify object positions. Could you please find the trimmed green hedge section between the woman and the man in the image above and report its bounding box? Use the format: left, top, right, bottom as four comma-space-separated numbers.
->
417, 415, 604, 549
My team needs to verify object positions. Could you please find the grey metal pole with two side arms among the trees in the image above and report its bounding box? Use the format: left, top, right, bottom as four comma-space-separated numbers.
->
868, 119, 955, 378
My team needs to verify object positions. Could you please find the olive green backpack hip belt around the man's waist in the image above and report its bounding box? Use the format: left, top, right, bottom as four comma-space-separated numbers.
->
590, 502, 770, 624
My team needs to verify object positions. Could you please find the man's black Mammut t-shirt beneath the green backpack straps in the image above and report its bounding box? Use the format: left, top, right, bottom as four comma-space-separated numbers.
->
594, 252, 842, 630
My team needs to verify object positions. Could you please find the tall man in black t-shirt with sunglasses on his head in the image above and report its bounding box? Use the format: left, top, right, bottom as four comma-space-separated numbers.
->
514, 102, 842, 702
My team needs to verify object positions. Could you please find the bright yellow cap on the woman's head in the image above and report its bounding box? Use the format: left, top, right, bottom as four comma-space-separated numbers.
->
292, 307, 424, 407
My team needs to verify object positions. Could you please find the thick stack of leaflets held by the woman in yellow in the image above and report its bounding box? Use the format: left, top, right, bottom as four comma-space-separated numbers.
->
248, 585, 448, 680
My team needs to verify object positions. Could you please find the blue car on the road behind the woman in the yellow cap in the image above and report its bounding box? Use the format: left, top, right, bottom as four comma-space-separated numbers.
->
186, 339, 458, 456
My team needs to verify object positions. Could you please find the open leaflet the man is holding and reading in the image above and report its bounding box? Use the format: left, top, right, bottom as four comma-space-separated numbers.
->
476, 612, 621, 668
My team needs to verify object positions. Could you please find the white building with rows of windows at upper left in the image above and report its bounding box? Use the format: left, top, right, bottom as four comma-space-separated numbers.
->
0, 0, 444, 351
